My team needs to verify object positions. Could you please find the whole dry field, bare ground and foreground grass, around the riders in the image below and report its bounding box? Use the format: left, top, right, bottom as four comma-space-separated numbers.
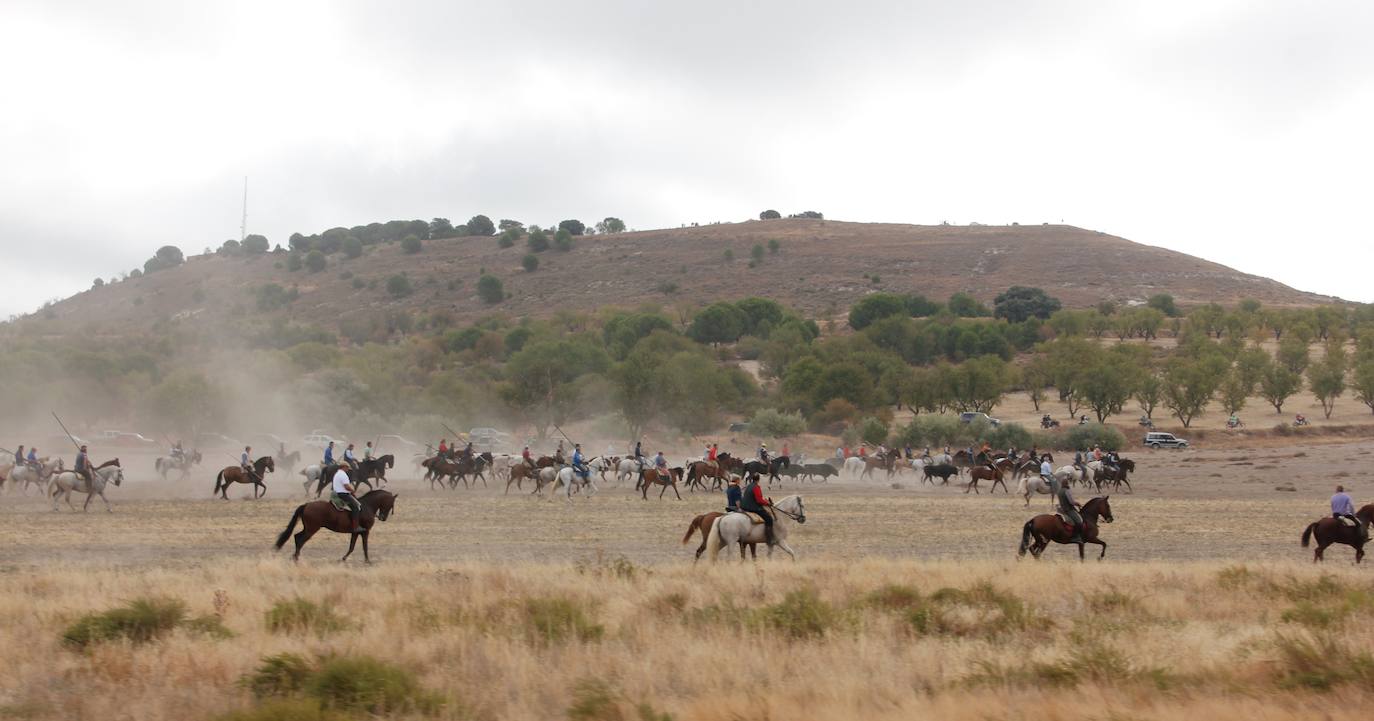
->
0, 441, 1374, 721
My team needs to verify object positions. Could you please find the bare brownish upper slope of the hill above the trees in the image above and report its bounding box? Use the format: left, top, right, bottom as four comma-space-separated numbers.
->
24, 220, 1331, 332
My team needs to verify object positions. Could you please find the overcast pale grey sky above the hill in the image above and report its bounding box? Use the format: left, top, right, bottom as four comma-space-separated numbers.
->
0, 0, 1374, 317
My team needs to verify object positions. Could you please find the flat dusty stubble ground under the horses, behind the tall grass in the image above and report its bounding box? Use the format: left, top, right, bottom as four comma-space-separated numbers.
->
0, 441, 1374, 571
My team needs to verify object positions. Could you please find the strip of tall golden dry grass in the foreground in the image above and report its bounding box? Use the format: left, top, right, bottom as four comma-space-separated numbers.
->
0, 560, 1374, 721
